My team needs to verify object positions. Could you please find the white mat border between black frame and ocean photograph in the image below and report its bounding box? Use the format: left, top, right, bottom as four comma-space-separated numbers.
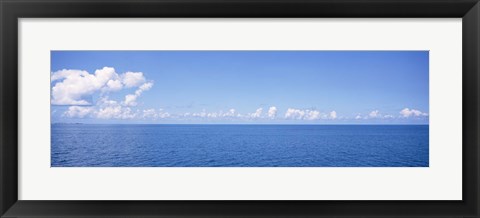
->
19, 19, 462, 200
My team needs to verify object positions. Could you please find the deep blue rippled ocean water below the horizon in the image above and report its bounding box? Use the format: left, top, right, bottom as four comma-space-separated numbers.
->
51, 124, 429, 167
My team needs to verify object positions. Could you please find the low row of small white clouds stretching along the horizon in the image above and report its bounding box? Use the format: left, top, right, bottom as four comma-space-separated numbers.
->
63, 103, 428, 122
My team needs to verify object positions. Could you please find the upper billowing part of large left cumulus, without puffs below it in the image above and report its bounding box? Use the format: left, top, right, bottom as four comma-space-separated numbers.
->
50, 67, 153, 105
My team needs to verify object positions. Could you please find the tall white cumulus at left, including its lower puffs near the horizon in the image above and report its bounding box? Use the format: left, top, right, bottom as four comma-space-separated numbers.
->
50, 67, 156, 119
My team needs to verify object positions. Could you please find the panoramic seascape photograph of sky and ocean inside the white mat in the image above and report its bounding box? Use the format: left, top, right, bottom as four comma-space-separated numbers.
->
50, 50, 429, 167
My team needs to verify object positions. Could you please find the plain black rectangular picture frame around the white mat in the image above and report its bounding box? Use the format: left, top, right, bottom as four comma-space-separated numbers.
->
0, 0, 480, 218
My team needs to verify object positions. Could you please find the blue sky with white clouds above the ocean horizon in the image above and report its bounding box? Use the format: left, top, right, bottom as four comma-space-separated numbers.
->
50, 51, 429, 124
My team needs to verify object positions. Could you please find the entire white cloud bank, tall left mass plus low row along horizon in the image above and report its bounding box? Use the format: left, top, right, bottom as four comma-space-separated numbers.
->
51, 67, 429, 123
